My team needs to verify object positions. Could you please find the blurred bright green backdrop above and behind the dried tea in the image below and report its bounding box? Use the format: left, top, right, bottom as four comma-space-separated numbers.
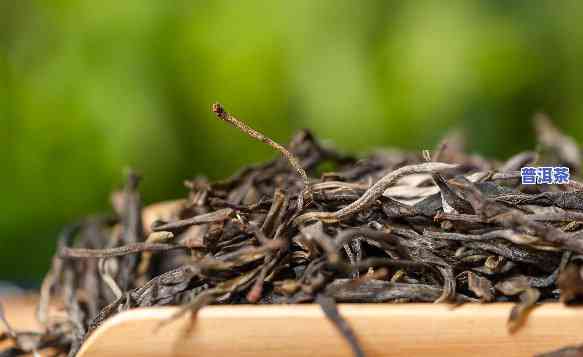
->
0, 0, 583, 283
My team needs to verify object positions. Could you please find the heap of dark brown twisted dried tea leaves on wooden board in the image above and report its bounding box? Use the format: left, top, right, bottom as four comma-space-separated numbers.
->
0, 104, 583, 356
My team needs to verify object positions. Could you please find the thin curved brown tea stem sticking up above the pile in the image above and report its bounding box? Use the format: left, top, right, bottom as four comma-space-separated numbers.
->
212, 103, 310, 208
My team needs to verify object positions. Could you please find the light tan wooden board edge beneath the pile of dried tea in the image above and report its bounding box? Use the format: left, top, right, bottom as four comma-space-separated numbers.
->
80, 304, 583, 357
